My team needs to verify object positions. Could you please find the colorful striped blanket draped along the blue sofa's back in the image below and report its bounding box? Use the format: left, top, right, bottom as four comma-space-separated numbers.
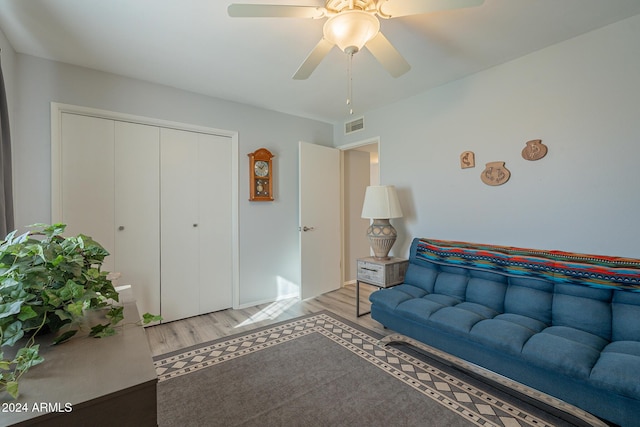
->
416, 239, 640, 292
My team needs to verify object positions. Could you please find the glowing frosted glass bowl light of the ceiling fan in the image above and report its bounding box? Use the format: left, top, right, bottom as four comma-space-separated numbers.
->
322, 10, 380, 53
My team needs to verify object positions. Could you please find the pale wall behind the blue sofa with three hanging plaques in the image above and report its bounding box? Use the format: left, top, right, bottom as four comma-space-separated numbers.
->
334, 16, 640, 258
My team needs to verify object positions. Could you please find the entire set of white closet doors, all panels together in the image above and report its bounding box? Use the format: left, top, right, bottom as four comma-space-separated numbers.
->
52, 107, 237, 322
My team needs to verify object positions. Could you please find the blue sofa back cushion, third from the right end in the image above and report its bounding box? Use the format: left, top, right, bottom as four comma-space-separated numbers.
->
504, 277, 553, 326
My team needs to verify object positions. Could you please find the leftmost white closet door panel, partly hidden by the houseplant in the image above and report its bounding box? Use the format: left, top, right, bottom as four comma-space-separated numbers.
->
59, 113, 114, 271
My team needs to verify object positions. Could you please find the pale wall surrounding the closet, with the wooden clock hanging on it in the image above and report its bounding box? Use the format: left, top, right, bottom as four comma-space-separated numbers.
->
13, 54, 332, 305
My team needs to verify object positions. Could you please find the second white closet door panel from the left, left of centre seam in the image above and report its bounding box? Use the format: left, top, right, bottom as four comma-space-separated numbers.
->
113, 122, 160, 320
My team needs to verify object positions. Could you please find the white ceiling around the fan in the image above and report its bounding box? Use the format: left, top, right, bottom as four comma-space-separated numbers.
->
0, 0, 640, 122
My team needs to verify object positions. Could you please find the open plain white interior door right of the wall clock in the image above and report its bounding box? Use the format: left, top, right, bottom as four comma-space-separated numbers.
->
299, 142, 341, 299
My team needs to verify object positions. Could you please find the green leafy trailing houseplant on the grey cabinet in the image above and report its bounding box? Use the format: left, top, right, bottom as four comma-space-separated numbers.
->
0, 224, 160, 398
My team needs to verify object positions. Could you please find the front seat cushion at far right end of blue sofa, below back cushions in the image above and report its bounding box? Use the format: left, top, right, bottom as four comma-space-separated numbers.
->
591, 341, 640, 399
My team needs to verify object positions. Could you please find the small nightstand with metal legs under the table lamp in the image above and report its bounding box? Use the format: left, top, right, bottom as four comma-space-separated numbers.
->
356, 257, 409, 317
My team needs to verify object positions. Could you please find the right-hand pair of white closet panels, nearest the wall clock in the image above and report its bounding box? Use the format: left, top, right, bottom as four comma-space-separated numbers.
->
160, 129, 232, 321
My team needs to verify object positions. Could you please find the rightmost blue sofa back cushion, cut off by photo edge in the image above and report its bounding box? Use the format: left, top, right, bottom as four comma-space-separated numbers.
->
611, 291, 640, 341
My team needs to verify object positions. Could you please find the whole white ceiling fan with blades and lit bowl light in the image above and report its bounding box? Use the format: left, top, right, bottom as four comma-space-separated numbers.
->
227, 0, 484, 80
